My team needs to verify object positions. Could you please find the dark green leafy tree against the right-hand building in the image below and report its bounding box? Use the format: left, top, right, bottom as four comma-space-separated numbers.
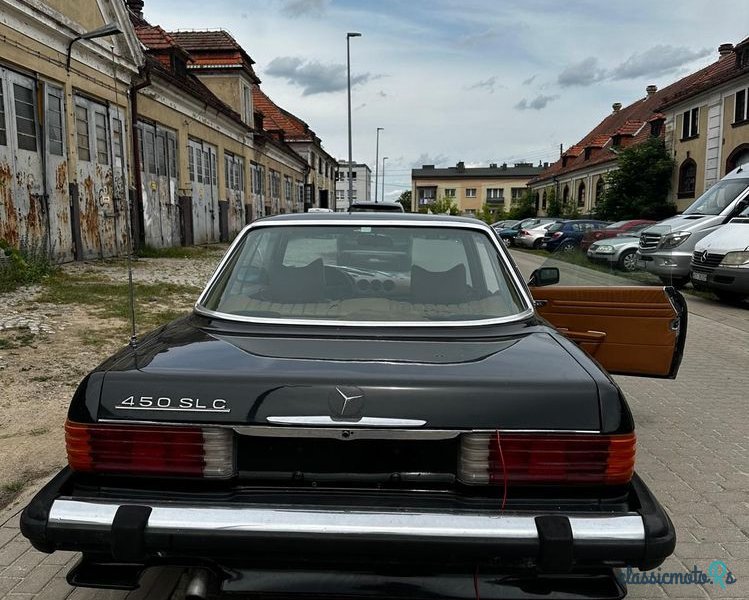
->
596, 138, 676, 221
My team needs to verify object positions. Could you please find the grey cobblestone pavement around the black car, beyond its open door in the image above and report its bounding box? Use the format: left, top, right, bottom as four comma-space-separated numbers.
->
0, 251, 749, 600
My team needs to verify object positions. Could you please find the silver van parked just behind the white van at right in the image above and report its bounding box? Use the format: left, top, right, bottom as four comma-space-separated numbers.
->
637, 165, 749, 287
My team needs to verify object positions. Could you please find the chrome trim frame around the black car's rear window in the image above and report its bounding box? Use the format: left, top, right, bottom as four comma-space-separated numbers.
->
193, 213, 535, 328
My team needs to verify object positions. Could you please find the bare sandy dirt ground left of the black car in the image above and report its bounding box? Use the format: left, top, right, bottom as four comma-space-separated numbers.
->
0, 247, 225, 507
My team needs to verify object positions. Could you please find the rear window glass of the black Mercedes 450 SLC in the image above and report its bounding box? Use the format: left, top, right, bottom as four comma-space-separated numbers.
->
200, 225, 529, 322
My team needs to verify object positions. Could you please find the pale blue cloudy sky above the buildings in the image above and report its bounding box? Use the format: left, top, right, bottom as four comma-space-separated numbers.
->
144, 0, 749, 200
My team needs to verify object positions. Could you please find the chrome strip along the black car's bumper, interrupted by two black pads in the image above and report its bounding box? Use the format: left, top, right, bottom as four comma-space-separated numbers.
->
48, 498, 645, 541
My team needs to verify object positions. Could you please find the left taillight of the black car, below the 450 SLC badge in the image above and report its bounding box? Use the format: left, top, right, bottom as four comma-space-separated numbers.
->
65, 421, 234, 477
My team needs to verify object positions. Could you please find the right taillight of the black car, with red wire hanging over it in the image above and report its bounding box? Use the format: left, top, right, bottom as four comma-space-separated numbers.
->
458, 433, 636, 485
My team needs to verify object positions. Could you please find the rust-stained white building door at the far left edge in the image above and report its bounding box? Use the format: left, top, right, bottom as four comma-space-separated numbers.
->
0, 68, 49, 254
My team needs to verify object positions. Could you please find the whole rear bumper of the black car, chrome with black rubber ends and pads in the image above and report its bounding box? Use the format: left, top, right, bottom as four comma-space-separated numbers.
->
21, 470, 675, 573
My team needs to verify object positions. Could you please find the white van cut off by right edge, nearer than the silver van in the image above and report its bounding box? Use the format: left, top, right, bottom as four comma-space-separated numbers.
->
692, 208, 749, 302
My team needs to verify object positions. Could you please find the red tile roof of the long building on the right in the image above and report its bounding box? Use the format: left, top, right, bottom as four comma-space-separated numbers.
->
530, 38, 749, 183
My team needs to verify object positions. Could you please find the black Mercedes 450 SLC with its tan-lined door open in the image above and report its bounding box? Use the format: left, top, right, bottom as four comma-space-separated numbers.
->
21, 213, 686, 598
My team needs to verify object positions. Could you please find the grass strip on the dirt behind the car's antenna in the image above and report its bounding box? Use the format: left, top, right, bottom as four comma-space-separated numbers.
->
38, 272, 201, 330
